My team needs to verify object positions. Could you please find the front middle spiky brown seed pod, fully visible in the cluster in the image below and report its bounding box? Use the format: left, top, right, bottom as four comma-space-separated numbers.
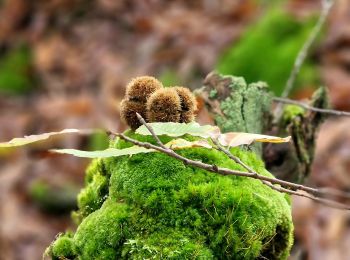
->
147, 88, 181, 122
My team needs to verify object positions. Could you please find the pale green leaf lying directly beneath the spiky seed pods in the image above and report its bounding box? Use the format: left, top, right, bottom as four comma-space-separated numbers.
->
136, 122, 220, 138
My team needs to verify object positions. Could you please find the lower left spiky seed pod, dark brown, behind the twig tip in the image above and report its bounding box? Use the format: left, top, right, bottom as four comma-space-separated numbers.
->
120, 99, 146, 130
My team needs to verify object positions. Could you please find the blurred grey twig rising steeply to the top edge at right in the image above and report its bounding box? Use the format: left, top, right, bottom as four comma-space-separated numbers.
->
275, 0, 334, 121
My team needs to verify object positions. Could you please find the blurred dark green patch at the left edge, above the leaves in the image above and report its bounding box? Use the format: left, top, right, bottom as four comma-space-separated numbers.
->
0, 46, 34, 95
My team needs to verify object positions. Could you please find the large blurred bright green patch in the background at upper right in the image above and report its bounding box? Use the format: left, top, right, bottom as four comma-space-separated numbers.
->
217, 8, 319, 95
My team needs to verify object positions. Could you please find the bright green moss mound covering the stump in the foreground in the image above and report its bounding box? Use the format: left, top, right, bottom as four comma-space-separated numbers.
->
48, 132, 293, 259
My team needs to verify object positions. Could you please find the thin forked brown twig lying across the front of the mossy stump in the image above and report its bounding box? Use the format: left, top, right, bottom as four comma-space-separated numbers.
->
115, 116, 350, 210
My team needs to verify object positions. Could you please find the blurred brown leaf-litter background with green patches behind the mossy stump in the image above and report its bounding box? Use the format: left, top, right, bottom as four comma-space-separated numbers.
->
0, 0, 350, 260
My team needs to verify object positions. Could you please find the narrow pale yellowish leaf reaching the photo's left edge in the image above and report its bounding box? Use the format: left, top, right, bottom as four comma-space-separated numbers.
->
0, 129, 96, 148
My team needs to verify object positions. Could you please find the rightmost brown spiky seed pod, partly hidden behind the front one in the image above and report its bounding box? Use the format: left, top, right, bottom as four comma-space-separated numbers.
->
174, 86, 197, 123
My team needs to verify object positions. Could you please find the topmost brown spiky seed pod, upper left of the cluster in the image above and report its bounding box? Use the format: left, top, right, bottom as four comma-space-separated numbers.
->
126, 76, 163, 103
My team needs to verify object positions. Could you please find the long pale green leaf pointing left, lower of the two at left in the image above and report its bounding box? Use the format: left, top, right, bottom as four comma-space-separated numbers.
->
50, 146, 155, 158
